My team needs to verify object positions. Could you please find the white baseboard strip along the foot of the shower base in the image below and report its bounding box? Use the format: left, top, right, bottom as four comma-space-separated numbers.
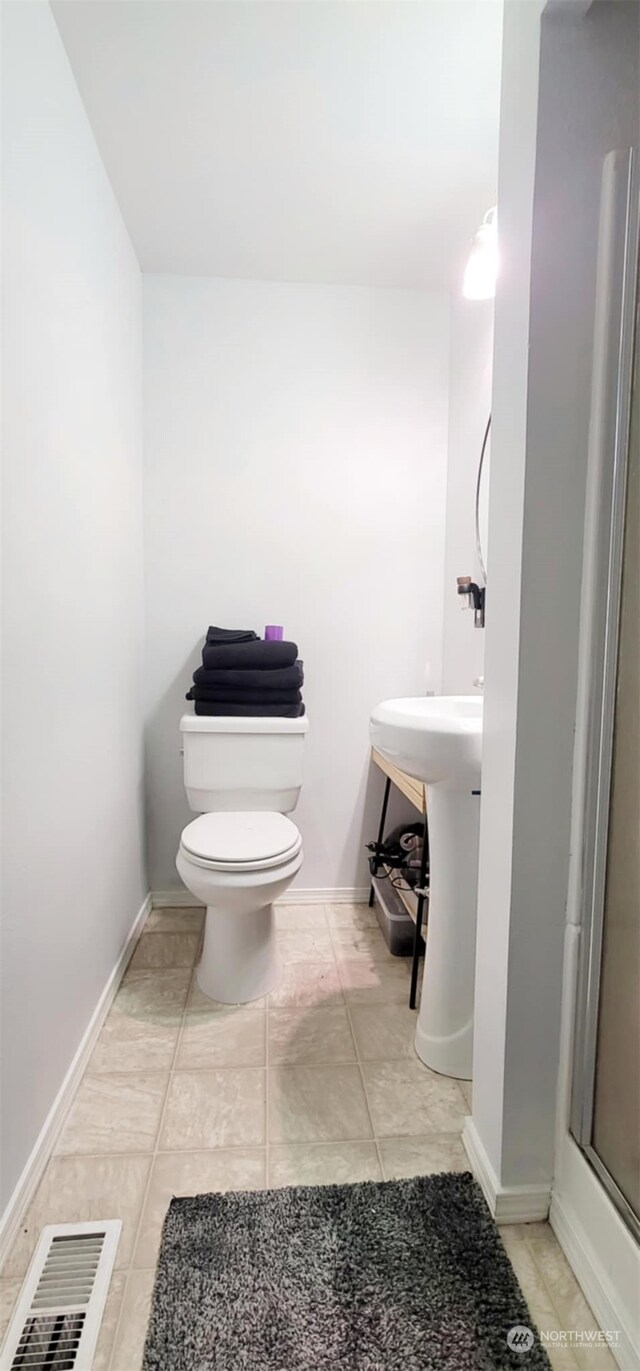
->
550, 1191, 640, 1371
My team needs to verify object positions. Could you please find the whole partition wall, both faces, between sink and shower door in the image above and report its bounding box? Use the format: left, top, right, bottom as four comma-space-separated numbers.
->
474, 0, 639, 1187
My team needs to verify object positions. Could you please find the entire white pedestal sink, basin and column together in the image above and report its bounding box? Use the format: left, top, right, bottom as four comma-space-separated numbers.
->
370, 695, 482, 1080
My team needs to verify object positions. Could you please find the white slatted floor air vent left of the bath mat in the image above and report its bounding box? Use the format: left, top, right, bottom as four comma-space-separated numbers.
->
0, 1219, 122, 1371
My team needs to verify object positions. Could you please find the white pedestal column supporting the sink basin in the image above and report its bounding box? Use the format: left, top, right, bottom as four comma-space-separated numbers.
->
415, 786, 480, 1080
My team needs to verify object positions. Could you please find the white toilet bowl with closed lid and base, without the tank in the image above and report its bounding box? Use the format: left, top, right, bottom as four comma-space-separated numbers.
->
175, 810, 303, 1004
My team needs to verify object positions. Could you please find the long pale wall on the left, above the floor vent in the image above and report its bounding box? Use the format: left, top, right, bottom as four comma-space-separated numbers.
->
0, 0, 145, 1208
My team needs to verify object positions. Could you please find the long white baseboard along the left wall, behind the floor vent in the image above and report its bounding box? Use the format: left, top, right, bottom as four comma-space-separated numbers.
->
0, 895, 151, 1268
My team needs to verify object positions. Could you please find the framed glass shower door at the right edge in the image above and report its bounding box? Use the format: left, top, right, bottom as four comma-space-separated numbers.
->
571, 152, 640, 1237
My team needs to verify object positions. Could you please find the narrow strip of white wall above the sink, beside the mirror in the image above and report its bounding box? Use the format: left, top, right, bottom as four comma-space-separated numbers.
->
443, 295, 493, 695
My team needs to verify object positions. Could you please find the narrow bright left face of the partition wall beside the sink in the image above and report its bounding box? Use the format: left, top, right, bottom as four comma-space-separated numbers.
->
473, 0, 544, 1185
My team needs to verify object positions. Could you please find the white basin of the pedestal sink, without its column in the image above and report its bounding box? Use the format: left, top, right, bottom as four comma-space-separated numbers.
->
370, 695, 482, 790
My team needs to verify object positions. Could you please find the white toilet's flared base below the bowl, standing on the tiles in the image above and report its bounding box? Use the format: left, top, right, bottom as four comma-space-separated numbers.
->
196, 905, 281, 1005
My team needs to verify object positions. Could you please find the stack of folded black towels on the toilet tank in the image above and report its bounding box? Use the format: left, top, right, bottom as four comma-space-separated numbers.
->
186, 628, 304, 718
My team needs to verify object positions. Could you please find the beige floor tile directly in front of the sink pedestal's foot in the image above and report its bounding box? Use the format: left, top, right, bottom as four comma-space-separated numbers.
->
362, 1060, 466, 1138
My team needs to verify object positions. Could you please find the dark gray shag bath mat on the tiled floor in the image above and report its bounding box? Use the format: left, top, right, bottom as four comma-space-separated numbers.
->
143, 1174, 550, 1371
